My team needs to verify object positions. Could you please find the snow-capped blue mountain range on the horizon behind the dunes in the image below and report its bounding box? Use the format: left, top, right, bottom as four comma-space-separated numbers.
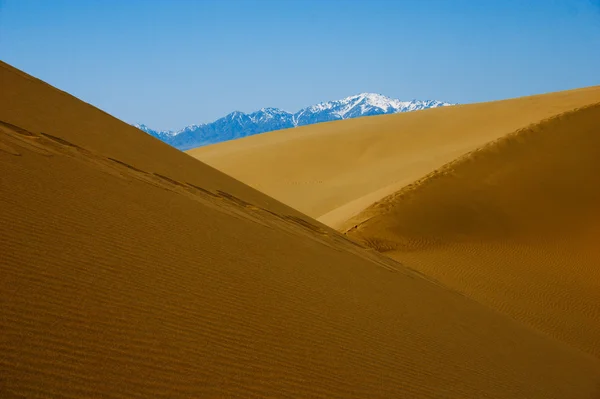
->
135, 93, 453, 150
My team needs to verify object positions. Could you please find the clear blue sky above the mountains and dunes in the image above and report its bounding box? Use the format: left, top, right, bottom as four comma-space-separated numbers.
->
0, 0, 600, 129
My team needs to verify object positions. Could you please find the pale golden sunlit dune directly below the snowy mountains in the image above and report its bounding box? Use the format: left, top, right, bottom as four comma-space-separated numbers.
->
189, 86, 600, 228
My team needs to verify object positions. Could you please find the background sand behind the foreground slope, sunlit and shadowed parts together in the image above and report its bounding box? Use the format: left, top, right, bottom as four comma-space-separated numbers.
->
189, 86, 600, 357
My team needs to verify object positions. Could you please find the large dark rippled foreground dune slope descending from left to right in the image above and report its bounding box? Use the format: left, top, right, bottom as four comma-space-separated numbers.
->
0, 64, 600, 399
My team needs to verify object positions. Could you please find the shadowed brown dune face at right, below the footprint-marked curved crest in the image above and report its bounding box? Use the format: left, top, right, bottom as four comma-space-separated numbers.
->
346, 105, 600, 356
